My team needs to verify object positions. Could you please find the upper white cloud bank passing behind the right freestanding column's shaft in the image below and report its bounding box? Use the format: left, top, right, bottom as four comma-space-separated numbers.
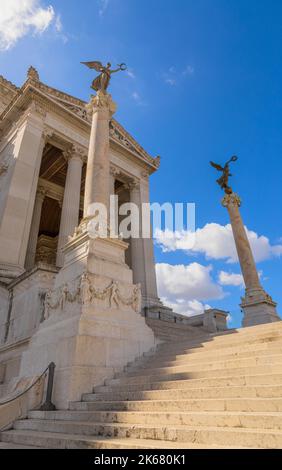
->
155, 223, 282, 263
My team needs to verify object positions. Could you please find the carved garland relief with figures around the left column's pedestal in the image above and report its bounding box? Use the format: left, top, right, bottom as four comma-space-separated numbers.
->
44, 273, 141, 320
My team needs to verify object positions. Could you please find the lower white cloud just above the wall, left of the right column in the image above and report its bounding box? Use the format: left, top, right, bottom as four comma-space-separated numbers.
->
156, 263, 224, 315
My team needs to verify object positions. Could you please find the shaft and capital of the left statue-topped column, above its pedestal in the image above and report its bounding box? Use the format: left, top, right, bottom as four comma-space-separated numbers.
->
84, 92, 116, 218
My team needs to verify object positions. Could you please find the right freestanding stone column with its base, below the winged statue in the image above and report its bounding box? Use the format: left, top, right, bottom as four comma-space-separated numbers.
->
222, 193, 280, 326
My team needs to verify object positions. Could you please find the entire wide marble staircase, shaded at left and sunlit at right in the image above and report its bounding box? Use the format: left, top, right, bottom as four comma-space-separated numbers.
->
0, 322, 282, 449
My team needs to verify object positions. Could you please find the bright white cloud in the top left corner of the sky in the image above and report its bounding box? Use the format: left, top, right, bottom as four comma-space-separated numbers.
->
0, 0, 56, 51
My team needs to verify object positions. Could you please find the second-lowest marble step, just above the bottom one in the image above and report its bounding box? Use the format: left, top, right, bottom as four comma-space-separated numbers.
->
14, 410, 282, 434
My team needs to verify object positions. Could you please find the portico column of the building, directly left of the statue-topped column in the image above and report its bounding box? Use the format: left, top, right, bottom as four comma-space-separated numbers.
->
56, 147, 84, 267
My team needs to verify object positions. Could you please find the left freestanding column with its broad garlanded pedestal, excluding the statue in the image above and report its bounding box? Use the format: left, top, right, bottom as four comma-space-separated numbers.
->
20, 93, 156, 408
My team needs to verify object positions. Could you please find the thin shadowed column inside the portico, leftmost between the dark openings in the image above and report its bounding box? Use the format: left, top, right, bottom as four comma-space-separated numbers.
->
25, 186, 46, 270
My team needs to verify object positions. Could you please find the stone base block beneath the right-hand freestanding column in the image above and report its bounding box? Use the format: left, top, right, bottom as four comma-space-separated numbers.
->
240, 288, 281, 327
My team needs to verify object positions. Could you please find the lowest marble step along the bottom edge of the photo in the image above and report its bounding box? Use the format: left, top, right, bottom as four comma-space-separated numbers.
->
2, 430, 242, 449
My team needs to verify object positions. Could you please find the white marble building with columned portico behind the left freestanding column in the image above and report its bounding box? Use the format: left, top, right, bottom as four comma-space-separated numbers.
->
0, 67, 226, 406
